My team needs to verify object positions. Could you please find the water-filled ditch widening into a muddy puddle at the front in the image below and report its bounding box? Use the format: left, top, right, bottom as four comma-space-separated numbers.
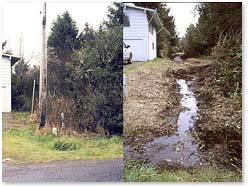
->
144, 79, 201, 167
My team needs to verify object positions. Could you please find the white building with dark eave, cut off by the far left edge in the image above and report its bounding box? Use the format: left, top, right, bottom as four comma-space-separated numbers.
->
0, 54, 21, 112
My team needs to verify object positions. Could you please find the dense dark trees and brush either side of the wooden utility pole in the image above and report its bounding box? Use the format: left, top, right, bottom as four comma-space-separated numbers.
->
10, 3, 123, 135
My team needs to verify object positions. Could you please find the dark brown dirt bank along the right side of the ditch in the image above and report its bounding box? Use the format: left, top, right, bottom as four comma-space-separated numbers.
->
167, 59, 242, 172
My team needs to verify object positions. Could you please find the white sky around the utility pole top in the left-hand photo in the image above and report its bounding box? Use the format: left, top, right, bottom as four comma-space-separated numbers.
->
2, 2, 111, 65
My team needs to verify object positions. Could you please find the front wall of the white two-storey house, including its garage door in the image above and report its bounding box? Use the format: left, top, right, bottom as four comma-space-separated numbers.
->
123, 7, 149, 61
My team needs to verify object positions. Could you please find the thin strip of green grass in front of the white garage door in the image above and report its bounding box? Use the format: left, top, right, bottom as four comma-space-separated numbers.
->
124, 58, 174, 74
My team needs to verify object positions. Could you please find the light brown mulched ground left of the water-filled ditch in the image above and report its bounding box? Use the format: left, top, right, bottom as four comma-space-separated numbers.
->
123, 59, 207, 152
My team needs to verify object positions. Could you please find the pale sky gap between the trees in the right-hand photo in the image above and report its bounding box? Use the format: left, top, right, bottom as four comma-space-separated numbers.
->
166, 3, 199, 37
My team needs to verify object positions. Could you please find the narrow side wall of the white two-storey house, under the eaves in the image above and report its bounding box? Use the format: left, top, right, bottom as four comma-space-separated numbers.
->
148, 25, 157, 60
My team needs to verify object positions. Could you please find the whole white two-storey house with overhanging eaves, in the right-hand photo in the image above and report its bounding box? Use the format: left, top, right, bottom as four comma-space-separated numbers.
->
123, 3, 162, 61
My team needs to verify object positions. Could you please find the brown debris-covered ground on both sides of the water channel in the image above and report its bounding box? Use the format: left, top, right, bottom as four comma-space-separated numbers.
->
123, 59, 242, 171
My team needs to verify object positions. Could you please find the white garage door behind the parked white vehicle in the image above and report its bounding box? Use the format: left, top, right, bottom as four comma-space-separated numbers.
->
124, 39, 147, 61
